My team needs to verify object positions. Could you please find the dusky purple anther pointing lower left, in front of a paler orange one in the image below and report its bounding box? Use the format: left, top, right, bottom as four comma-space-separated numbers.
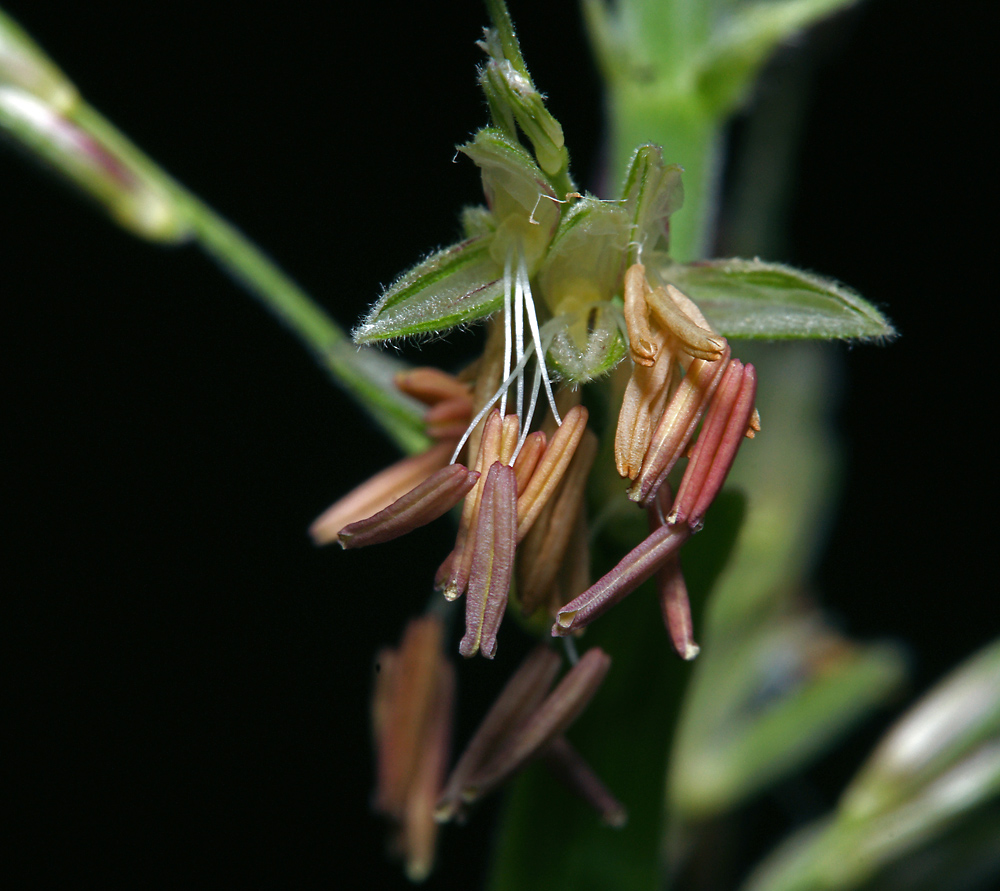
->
338, 464, 479, 549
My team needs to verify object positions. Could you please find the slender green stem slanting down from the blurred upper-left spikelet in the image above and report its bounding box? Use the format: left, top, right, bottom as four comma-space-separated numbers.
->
72, 102, 428, 452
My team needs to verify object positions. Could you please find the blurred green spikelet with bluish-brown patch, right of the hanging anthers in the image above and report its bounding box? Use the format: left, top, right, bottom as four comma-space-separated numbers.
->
670, 615, 905, 821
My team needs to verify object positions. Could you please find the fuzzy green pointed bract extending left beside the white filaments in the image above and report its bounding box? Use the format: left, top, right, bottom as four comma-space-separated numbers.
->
353, 237, 503, 343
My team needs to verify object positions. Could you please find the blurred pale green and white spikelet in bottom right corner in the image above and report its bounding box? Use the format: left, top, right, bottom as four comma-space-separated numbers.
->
745, 641, 1000, 891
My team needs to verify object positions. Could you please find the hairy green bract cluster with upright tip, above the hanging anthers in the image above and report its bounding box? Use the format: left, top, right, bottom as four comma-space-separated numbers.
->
354, 10, 894, 372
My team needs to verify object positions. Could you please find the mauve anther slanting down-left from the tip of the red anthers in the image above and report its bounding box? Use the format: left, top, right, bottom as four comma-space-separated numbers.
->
552, 525, 691, 637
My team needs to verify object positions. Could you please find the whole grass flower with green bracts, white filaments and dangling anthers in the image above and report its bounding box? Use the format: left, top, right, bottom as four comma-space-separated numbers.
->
311, 3, 891, 873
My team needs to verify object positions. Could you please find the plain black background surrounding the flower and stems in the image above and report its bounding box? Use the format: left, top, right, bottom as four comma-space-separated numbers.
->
0, 0, 998, 888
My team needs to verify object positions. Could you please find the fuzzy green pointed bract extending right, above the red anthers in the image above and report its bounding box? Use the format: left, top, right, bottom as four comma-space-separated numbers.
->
661, 259, 896, 340
